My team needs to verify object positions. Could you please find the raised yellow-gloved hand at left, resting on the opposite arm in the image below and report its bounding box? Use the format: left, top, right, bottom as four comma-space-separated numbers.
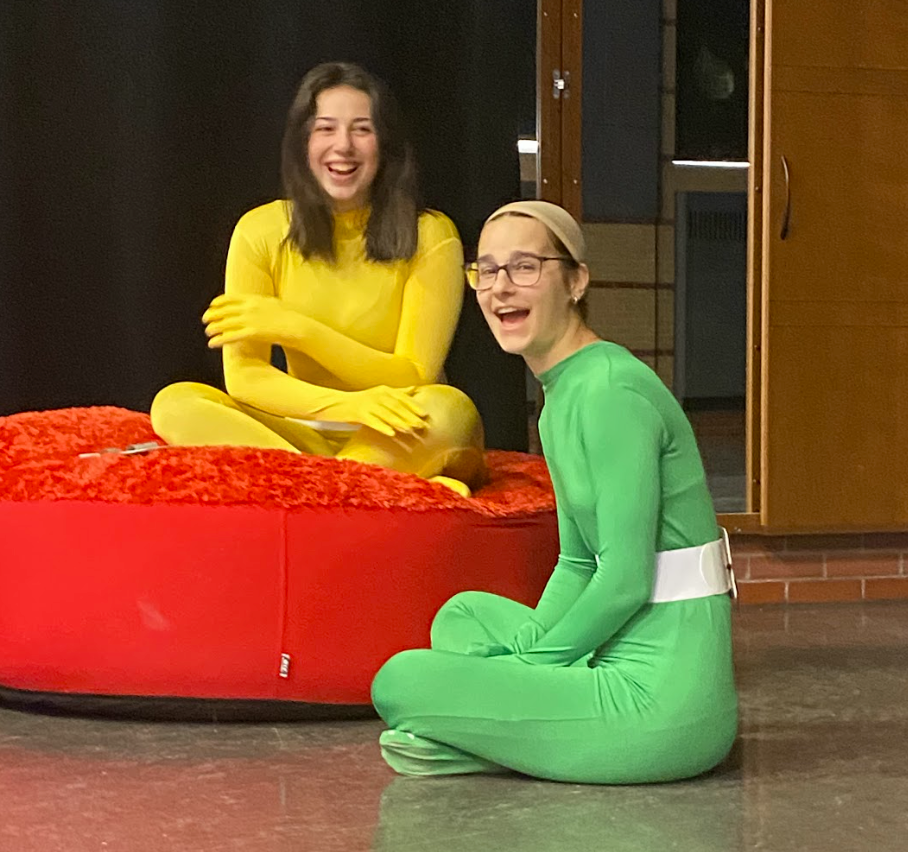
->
202, 295, 307, 349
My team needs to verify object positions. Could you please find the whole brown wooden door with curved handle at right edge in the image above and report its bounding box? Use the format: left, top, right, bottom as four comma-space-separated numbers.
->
760, 0, 908, 531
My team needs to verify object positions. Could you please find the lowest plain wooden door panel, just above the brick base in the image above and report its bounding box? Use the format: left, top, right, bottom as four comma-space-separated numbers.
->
762, 322, 908, 532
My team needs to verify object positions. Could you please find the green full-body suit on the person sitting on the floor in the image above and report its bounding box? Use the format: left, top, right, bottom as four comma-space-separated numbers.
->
372, 341, 737, 784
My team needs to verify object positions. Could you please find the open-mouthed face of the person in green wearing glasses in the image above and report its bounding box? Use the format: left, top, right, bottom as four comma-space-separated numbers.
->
476, 215, 596, 375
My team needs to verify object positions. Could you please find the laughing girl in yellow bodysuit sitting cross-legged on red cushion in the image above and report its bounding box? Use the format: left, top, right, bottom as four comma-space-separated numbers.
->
151, 63, 484, 495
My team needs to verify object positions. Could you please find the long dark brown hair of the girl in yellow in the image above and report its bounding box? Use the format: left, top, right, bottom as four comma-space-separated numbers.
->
281, 62, 423, 262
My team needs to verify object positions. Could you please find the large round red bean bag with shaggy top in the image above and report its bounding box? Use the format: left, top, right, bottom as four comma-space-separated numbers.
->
0, 407, 557, 715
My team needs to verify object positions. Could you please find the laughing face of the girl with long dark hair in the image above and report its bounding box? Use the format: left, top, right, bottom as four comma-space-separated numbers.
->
308, 86, 378, 213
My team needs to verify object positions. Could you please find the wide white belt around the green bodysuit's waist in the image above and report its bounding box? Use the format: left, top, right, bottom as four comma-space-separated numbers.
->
650, 527, 738, 603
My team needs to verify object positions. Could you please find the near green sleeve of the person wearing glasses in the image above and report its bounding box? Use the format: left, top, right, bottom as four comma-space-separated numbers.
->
516, 388, 664, 666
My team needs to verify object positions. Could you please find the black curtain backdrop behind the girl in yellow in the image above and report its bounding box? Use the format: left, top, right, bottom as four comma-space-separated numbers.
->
0, 0, 535, 449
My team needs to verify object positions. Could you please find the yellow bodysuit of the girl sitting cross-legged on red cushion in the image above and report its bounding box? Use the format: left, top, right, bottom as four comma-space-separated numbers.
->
151, 201, 484, 487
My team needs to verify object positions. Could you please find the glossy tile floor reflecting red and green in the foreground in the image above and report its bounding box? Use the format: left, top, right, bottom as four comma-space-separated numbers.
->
0, 603, 908, 852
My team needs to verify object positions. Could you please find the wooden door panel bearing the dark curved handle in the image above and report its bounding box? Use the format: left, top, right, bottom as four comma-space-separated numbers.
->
767, 89, 908, 302
